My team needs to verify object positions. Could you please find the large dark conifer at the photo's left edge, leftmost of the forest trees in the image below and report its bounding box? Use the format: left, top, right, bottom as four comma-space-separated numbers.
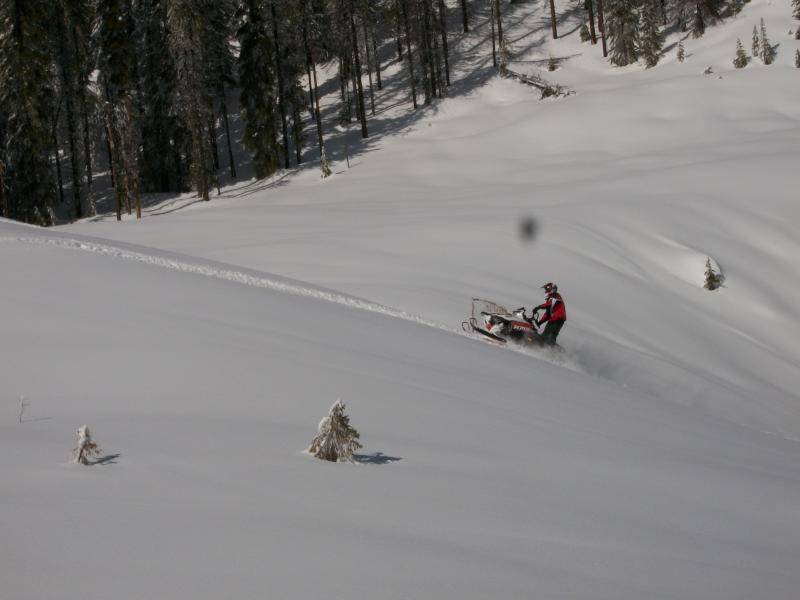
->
0, 0, 55, 225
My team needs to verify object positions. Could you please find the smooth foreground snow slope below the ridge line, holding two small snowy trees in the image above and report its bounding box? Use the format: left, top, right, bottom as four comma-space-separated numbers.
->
0, 223, 800, 599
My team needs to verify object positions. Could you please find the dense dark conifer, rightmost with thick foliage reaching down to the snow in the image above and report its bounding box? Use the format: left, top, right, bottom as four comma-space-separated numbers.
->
237, 0, 281, 179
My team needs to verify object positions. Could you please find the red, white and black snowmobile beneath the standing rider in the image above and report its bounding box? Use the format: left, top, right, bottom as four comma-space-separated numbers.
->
461, 298, 544, 346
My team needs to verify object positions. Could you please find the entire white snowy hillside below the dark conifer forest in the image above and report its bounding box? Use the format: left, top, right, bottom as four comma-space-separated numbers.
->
0, 0, 800, 600
